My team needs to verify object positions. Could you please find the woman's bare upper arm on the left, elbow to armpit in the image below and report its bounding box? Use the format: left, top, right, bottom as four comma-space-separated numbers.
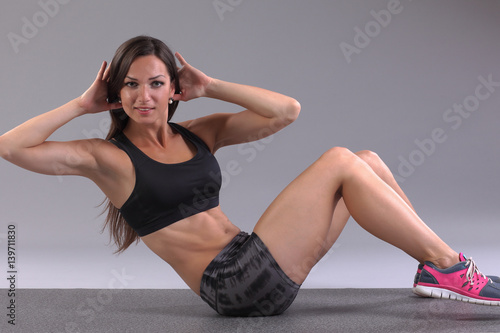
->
6, 139, 103, 176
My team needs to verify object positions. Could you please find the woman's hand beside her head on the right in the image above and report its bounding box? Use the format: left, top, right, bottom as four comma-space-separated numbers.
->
173, 52, 212, 102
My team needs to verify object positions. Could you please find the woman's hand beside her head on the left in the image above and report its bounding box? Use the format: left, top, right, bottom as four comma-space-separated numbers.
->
78, 61, 122, 113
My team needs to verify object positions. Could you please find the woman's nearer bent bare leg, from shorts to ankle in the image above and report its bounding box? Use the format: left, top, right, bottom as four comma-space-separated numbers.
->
254, 148, 458, 284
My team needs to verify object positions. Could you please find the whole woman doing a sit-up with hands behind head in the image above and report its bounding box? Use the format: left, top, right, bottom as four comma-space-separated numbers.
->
0, 36, 500, 316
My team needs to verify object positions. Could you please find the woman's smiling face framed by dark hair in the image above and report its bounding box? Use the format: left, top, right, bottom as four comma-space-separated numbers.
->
120, 55, 175, 124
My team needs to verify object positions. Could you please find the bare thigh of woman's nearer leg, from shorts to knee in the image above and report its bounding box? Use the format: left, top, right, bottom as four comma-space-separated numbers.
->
254, 148, 356, 284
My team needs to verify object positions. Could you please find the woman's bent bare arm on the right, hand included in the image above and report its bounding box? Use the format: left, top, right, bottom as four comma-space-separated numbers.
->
174, 53, 300, 152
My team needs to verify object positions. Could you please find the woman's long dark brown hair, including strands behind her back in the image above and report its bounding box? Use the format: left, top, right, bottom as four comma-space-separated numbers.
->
103, 36, 180, 253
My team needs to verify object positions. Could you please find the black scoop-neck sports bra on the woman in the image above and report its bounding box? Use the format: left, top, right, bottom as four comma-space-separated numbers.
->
110, 123, 222, 237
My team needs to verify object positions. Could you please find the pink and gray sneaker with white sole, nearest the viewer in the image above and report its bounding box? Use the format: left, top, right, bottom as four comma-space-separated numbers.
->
413, 253, 500, 305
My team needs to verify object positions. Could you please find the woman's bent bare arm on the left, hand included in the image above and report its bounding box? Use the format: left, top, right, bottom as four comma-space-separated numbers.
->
0, 62, 121, 175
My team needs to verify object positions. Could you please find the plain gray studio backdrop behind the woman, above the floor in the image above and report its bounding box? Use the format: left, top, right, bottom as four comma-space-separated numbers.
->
0, 0, 500, 288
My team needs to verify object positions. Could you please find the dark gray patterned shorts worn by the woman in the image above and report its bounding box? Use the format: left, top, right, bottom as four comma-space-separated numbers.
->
200, 232, 300, 317
